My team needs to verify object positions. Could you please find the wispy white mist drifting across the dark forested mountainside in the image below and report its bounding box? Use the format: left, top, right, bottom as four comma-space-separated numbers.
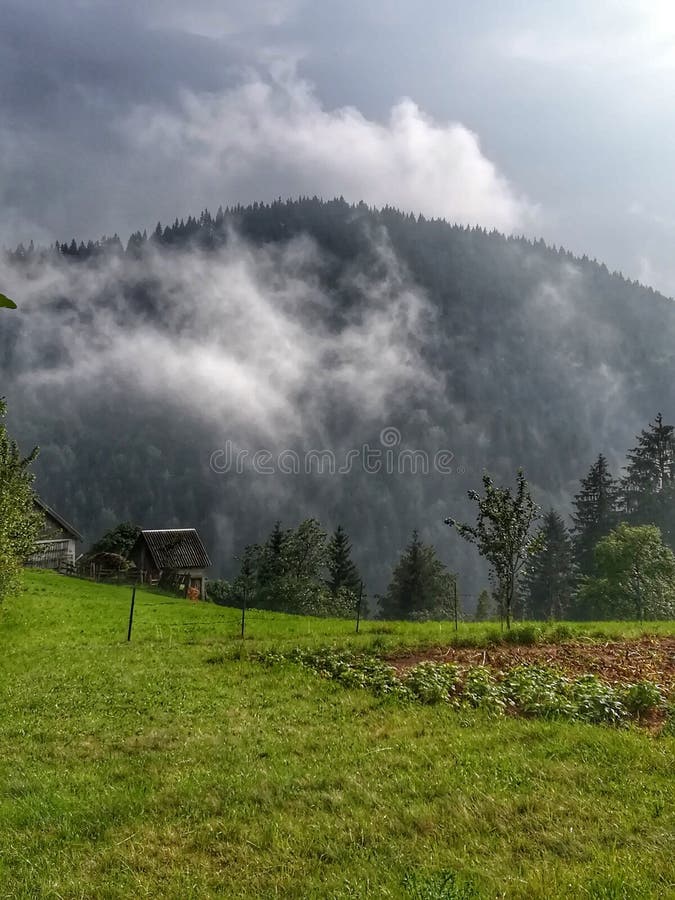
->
5, 234, 438, 447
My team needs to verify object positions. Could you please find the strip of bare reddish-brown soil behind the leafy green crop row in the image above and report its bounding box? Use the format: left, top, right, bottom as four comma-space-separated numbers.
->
387, 636, 675, 691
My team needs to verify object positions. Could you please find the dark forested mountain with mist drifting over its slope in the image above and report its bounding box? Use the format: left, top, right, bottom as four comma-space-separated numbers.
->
0, 199, 675, 605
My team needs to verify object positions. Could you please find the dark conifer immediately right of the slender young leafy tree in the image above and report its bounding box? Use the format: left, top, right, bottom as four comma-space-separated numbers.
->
524, 509, 575, 619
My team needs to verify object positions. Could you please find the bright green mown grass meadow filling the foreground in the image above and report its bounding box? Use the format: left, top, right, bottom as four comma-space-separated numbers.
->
0, 573, 675, 898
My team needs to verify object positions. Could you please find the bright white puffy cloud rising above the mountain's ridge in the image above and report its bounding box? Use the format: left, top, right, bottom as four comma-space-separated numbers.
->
120, 72, 536, 232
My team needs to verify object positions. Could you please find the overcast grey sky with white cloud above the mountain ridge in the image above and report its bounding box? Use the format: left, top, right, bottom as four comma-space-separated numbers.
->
0, 0, 675, 295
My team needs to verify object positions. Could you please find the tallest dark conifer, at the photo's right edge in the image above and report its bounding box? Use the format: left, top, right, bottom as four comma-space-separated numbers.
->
622, 413, 675, 547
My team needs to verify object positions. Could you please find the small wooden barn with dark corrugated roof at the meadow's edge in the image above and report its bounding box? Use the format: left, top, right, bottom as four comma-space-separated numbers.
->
129, 528, 211, 600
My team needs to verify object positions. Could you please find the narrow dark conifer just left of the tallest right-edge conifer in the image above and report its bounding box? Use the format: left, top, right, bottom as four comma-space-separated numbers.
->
572, 453, 619, 575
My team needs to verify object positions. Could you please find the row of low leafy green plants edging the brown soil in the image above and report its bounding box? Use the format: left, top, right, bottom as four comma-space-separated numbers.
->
258, 647, 675, 725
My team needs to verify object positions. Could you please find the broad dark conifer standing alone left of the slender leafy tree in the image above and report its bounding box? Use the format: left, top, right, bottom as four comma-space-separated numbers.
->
379, 530, 455, 619
